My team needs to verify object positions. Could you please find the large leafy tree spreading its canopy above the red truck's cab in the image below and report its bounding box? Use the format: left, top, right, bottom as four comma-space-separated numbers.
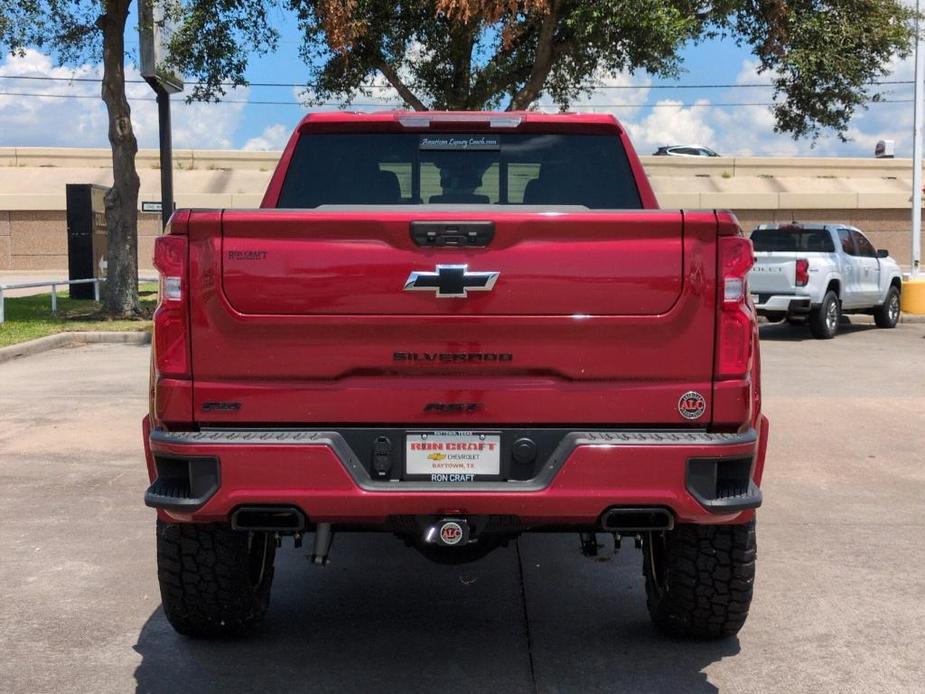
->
289, 0, 915, 137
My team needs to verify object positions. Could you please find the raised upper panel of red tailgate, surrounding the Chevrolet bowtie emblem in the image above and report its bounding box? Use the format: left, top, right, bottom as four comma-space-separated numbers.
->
222, 211, 682, 316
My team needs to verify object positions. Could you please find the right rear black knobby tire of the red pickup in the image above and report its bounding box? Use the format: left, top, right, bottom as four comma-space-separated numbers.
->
643, 521, 757, 639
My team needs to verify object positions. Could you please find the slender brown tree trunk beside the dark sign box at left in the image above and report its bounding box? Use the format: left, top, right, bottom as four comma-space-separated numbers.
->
97, 0, 139, 317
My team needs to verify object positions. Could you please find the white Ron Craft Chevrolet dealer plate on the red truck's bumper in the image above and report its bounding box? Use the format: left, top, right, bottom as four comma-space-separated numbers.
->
405, 431, 501, 482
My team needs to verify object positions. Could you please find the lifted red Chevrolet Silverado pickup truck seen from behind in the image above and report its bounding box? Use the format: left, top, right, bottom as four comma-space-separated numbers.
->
144, 112, 768, 638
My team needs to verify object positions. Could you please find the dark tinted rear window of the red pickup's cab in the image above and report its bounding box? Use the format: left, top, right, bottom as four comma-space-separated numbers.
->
278, 133, 642, 209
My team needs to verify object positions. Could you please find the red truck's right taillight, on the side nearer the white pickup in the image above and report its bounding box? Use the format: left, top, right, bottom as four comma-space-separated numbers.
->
716, 236, 755, 379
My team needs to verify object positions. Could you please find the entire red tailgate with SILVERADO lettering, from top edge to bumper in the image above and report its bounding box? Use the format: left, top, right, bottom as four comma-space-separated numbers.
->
189, 208, 717, 427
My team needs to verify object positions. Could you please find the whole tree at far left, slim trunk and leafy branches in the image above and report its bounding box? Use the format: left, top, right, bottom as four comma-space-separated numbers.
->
0, 0, 277, 316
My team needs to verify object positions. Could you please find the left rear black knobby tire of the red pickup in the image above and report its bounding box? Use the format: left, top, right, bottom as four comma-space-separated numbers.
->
157, 521, 276, 637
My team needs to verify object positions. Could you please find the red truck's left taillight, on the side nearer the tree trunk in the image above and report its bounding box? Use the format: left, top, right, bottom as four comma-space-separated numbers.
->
154, 234, 190, 378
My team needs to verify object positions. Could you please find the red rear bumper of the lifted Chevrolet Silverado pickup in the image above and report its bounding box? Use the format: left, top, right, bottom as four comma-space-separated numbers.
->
145, 418, 767, 525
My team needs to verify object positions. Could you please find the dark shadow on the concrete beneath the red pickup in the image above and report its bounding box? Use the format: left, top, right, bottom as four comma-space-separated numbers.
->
135, 535, 739, 694
